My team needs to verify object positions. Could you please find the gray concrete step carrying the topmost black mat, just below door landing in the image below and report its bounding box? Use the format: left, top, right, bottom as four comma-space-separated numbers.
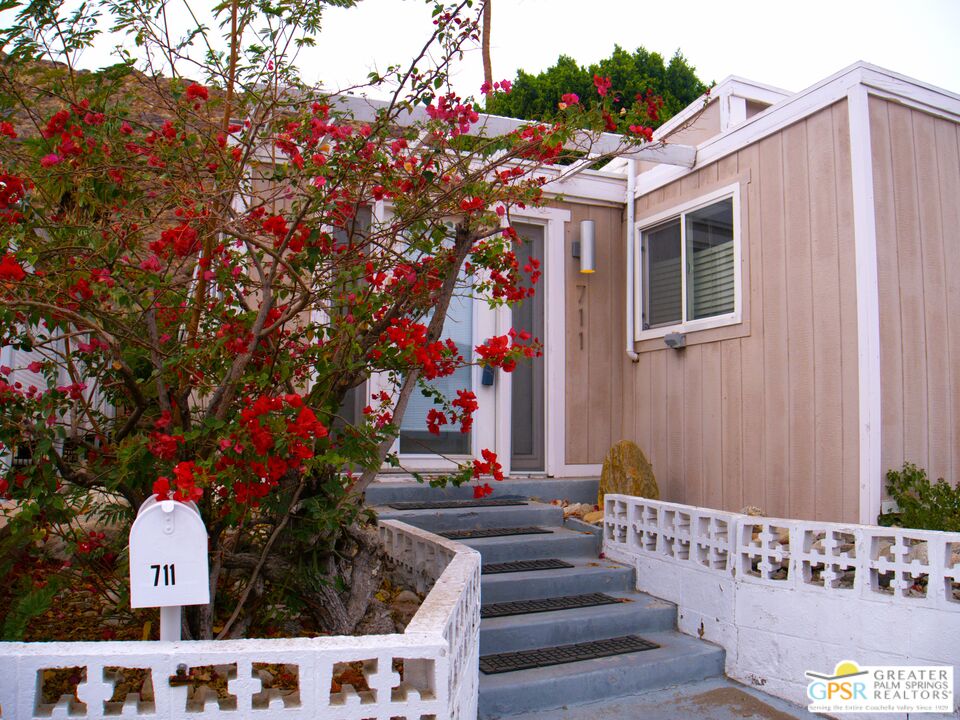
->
374, 502, 563, 532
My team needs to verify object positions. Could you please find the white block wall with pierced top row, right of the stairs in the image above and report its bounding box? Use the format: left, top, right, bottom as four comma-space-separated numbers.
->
603, 495, 960, 717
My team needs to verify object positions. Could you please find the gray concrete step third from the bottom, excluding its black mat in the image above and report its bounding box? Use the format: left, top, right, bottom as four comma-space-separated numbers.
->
481, 558, 634, 603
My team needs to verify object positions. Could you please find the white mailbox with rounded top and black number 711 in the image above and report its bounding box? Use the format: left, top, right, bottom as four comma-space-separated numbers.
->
130, 497, 210, 608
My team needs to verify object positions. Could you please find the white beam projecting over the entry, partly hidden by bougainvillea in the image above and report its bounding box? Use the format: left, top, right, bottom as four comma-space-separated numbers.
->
331, 95, 697, 167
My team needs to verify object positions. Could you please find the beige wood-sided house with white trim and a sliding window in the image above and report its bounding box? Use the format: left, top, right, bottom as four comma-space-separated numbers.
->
384, 63, 960, 522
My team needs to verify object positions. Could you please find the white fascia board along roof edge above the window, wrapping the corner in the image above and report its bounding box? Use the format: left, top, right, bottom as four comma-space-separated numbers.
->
636, 62, 960, 197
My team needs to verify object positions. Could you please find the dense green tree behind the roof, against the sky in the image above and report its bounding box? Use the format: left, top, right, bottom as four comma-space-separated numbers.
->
488, 45, 708, 127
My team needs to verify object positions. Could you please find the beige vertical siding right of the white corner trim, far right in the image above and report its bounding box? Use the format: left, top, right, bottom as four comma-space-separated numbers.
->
870, 98, 960, 490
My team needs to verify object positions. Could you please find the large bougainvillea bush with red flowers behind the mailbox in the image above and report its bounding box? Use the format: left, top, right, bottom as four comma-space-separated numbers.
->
0, 0, 649, 638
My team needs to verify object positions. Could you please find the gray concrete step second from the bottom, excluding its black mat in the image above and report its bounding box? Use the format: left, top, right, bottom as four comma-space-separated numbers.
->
480, 591, 677, 655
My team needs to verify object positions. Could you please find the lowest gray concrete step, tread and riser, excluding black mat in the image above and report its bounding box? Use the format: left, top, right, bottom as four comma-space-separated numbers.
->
479, 632, 724, 720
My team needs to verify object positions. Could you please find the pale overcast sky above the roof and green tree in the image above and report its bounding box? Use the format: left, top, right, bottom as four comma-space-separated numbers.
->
304, 0, 960, 94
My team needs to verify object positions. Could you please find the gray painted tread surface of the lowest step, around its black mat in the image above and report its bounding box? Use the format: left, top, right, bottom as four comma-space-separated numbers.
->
480, 631, 723, 695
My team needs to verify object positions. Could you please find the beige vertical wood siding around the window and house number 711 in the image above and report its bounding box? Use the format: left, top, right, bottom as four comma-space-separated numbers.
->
567, 101, 864, 521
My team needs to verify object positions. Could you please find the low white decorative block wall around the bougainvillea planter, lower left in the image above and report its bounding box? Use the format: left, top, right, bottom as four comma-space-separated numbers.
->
0, 520, 480, 720
